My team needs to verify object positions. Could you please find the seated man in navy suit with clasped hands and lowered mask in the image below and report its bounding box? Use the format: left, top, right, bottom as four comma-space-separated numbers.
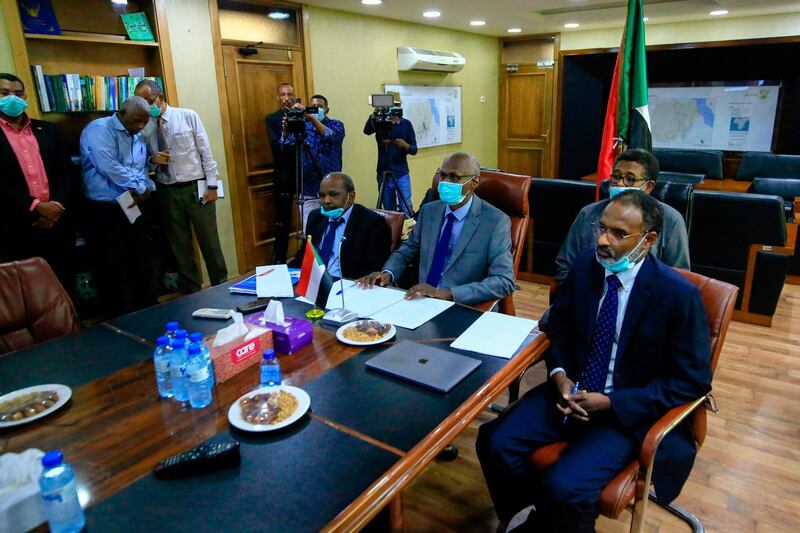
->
477, 191, 711, 532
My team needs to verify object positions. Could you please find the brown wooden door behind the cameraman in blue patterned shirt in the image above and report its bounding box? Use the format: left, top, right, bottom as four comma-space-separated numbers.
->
222, 45, 306, 272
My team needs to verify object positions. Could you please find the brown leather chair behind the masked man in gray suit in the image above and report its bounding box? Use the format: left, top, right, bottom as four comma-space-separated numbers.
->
475, 170, 531, 315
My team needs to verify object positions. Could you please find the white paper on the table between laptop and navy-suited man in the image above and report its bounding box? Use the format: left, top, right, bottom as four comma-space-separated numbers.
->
450, 313, 539, 359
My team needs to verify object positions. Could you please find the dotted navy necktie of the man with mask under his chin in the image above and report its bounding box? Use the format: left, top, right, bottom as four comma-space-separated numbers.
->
580, 275, 622, 392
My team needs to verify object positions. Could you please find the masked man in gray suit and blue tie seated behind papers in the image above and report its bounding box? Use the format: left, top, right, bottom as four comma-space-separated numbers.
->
358, 152, 514, 305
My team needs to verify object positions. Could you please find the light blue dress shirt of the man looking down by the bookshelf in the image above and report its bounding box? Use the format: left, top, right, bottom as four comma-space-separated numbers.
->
81, 113, 156, 202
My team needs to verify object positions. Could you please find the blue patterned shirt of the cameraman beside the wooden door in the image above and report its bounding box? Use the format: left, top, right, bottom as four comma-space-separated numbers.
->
281, 117, 345, 198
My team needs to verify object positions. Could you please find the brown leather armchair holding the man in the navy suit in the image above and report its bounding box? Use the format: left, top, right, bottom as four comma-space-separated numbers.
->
530, 269, 739, 532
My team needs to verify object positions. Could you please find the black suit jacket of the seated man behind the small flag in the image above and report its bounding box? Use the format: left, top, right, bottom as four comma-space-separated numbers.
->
289, 204, 392, 279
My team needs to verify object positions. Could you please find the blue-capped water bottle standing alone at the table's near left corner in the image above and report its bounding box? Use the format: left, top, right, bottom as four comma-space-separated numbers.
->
39, 450, 86, 533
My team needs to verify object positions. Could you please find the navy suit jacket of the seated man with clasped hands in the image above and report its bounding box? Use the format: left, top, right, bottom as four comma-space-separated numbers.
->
545, 250, 711, 502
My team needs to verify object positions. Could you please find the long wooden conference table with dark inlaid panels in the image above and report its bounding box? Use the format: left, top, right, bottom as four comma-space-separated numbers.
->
0, 284, 548, 532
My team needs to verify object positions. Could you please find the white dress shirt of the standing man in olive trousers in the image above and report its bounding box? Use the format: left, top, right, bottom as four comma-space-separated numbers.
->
142, 105, 219, 186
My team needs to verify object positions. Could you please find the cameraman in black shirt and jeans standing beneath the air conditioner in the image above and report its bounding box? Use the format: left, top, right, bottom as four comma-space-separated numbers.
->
364, 94, 417, 217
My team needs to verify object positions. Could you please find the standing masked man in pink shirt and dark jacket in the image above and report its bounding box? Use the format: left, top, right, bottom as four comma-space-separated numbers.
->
0, 73, 75, 292
